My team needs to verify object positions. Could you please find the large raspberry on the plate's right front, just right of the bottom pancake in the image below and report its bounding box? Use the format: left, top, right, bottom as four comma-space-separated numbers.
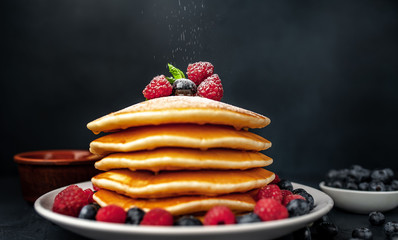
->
254, 198, 289, 221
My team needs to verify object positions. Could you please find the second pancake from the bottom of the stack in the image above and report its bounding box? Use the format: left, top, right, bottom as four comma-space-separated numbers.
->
91, 168, 275, 198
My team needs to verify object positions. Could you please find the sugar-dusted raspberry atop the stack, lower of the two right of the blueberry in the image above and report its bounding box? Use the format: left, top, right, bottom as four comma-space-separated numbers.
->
197, 74, 224, 101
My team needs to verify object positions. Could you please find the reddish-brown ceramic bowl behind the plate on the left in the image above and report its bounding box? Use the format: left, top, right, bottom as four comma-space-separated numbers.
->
14, 150, 99, 203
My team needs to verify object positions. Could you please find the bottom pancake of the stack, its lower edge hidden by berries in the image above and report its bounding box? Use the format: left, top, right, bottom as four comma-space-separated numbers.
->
93, 189, 256, 216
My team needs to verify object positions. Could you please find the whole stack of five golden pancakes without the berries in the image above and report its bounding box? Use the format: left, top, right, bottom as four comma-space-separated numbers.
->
87, 96, 275, 215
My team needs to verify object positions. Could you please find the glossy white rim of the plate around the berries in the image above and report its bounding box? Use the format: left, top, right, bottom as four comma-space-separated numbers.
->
34, 181, 334, 236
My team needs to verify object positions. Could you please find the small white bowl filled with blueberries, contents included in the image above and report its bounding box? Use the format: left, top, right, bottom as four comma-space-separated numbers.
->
319, 165, 398, 214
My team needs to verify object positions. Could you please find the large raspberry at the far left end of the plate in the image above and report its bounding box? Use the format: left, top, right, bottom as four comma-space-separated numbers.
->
52, 185, 88, 217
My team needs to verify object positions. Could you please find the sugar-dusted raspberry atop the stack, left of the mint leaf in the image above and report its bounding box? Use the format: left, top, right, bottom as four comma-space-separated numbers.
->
142, 75, 173, 100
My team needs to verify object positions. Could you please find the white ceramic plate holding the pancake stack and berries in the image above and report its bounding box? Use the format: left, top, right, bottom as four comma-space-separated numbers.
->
34, 182, 333, 240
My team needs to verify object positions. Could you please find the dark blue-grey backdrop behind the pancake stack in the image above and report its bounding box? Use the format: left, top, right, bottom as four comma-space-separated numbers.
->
0, 0, 398, 178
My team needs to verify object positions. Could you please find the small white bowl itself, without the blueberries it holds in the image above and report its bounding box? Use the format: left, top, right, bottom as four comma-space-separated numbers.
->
319, 182, 398, 214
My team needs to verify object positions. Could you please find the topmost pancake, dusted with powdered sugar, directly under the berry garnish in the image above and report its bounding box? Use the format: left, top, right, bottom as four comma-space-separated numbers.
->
87, 96, 270, 134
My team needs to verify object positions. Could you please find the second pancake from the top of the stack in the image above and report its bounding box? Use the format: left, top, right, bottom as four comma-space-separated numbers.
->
90, 124, 271, 155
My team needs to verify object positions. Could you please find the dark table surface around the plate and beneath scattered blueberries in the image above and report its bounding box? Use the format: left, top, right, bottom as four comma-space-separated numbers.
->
0, 176, 398, 240
